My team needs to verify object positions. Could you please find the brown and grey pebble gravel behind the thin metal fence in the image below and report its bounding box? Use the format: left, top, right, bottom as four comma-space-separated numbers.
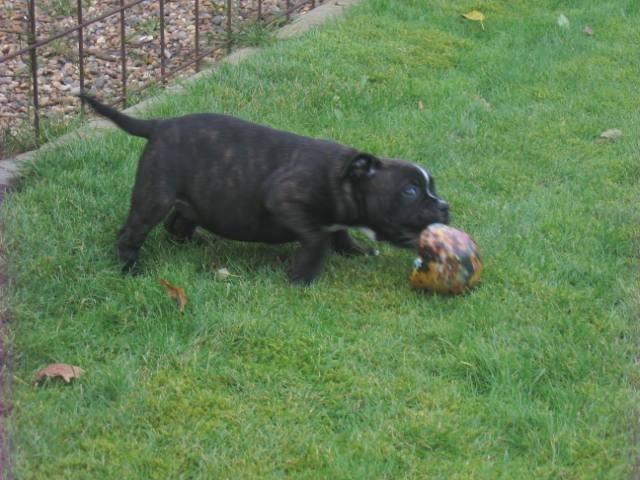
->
0, 0, 310, 158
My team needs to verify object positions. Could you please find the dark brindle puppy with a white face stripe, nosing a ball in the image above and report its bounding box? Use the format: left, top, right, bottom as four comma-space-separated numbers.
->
81, 95, 449, 283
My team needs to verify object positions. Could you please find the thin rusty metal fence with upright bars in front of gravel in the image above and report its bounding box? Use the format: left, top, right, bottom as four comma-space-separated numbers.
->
0, 0, 321, 149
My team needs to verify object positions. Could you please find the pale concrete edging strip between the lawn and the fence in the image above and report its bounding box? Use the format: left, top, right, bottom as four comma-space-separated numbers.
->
0, 0, 360, 190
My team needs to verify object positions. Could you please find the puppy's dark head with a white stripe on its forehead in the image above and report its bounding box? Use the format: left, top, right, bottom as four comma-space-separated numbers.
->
347, 154, 449, 248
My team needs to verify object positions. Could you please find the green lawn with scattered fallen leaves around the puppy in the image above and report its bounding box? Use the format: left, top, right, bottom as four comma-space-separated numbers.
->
2, 0, 640, 479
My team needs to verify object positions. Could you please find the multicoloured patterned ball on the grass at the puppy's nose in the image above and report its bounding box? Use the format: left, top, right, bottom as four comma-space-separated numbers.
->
409, 223, 482, 293
